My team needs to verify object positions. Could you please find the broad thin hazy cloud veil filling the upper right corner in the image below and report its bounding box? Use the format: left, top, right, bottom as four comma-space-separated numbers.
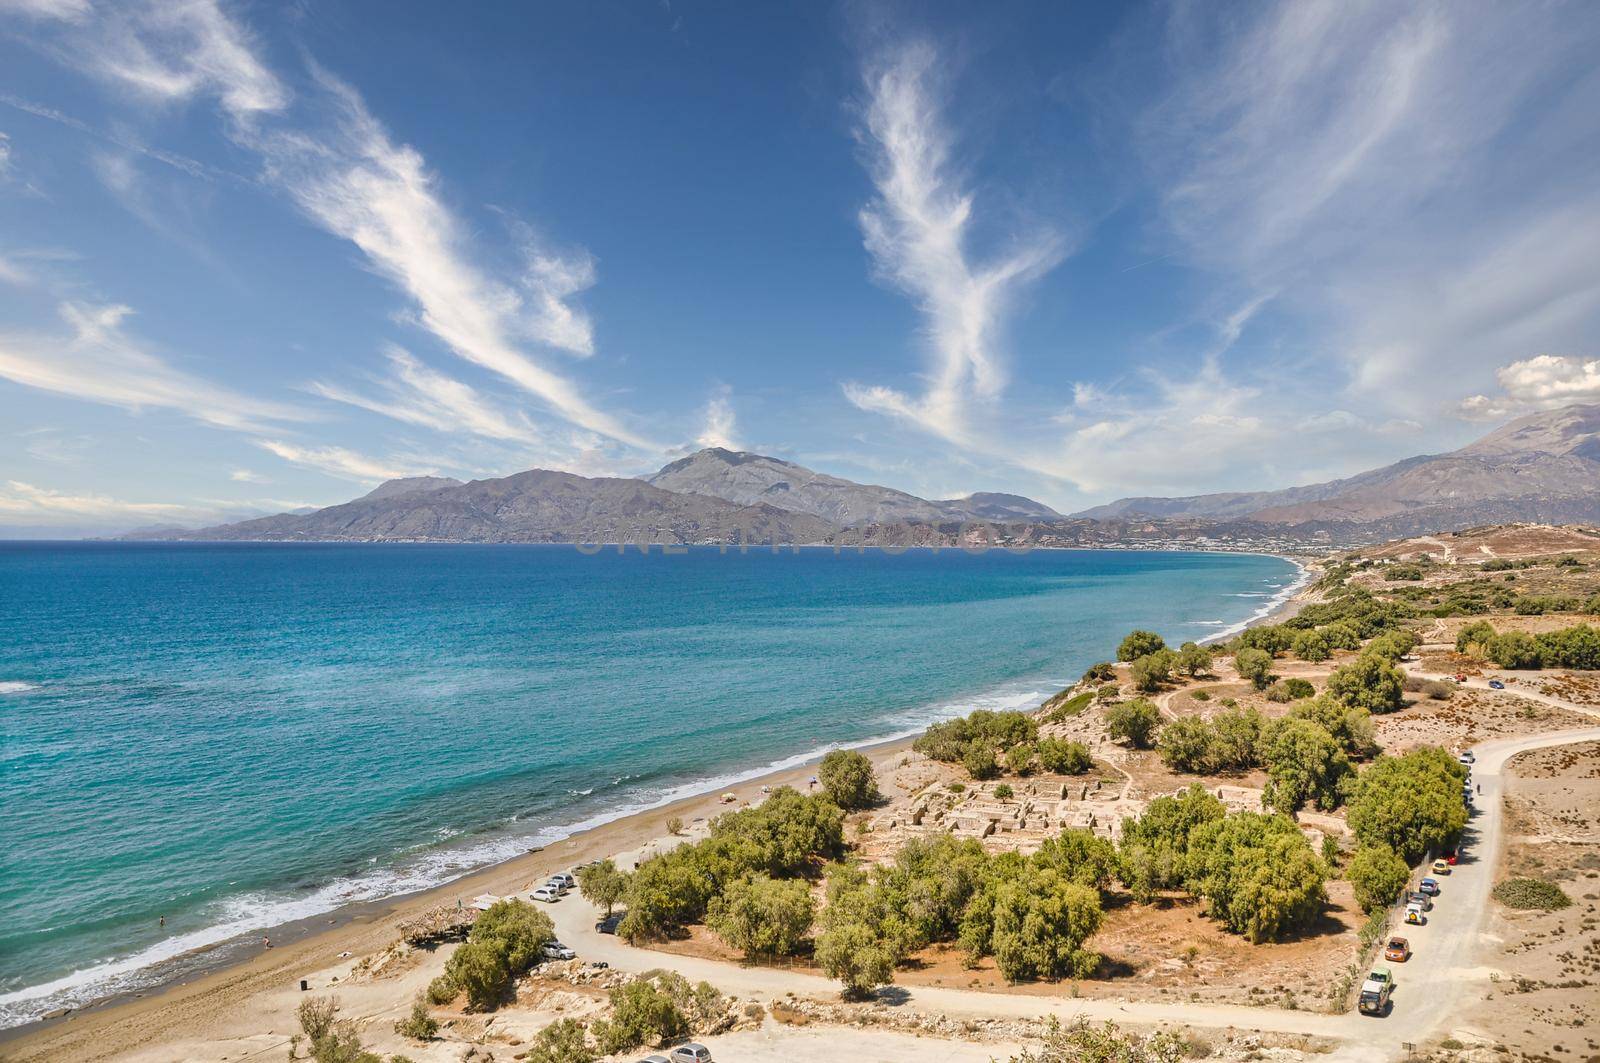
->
1122, 0, 1600, 409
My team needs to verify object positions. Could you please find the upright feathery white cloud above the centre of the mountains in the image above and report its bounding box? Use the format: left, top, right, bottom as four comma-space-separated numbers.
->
845, 43, 1062, 442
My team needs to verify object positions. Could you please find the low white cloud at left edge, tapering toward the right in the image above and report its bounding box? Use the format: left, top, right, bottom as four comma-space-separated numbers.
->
0, 303, 306, 431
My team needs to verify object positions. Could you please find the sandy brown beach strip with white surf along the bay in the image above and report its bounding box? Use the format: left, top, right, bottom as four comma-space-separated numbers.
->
0, 548, 1314, 1052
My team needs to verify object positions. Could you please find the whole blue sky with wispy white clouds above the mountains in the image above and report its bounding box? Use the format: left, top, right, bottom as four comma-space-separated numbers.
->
0, 0, 1600, 535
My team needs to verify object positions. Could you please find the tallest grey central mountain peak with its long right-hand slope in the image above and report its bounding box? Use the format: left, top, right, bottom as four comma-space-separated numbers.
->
650, 447, 1061, 527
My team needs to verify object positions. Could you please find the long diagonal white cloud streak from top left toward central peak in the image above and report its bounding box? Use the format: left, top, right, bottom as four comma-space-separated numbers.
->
6, 0, 661, 450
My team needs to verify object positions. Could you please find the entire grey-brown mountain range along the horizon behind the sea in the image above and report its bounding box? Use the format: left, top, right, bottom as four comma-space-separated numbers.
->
128, 405, 1600, 546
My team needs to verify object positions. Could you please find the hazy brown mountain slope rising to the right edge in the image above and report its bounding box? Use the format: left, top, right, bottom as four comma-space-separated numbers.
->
1077, 405, 1600, 535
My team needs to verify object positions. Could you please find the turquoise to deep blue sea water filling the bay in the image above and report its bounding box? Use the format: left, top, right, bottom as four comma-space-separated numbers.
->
0, 543, 1298, 1026
